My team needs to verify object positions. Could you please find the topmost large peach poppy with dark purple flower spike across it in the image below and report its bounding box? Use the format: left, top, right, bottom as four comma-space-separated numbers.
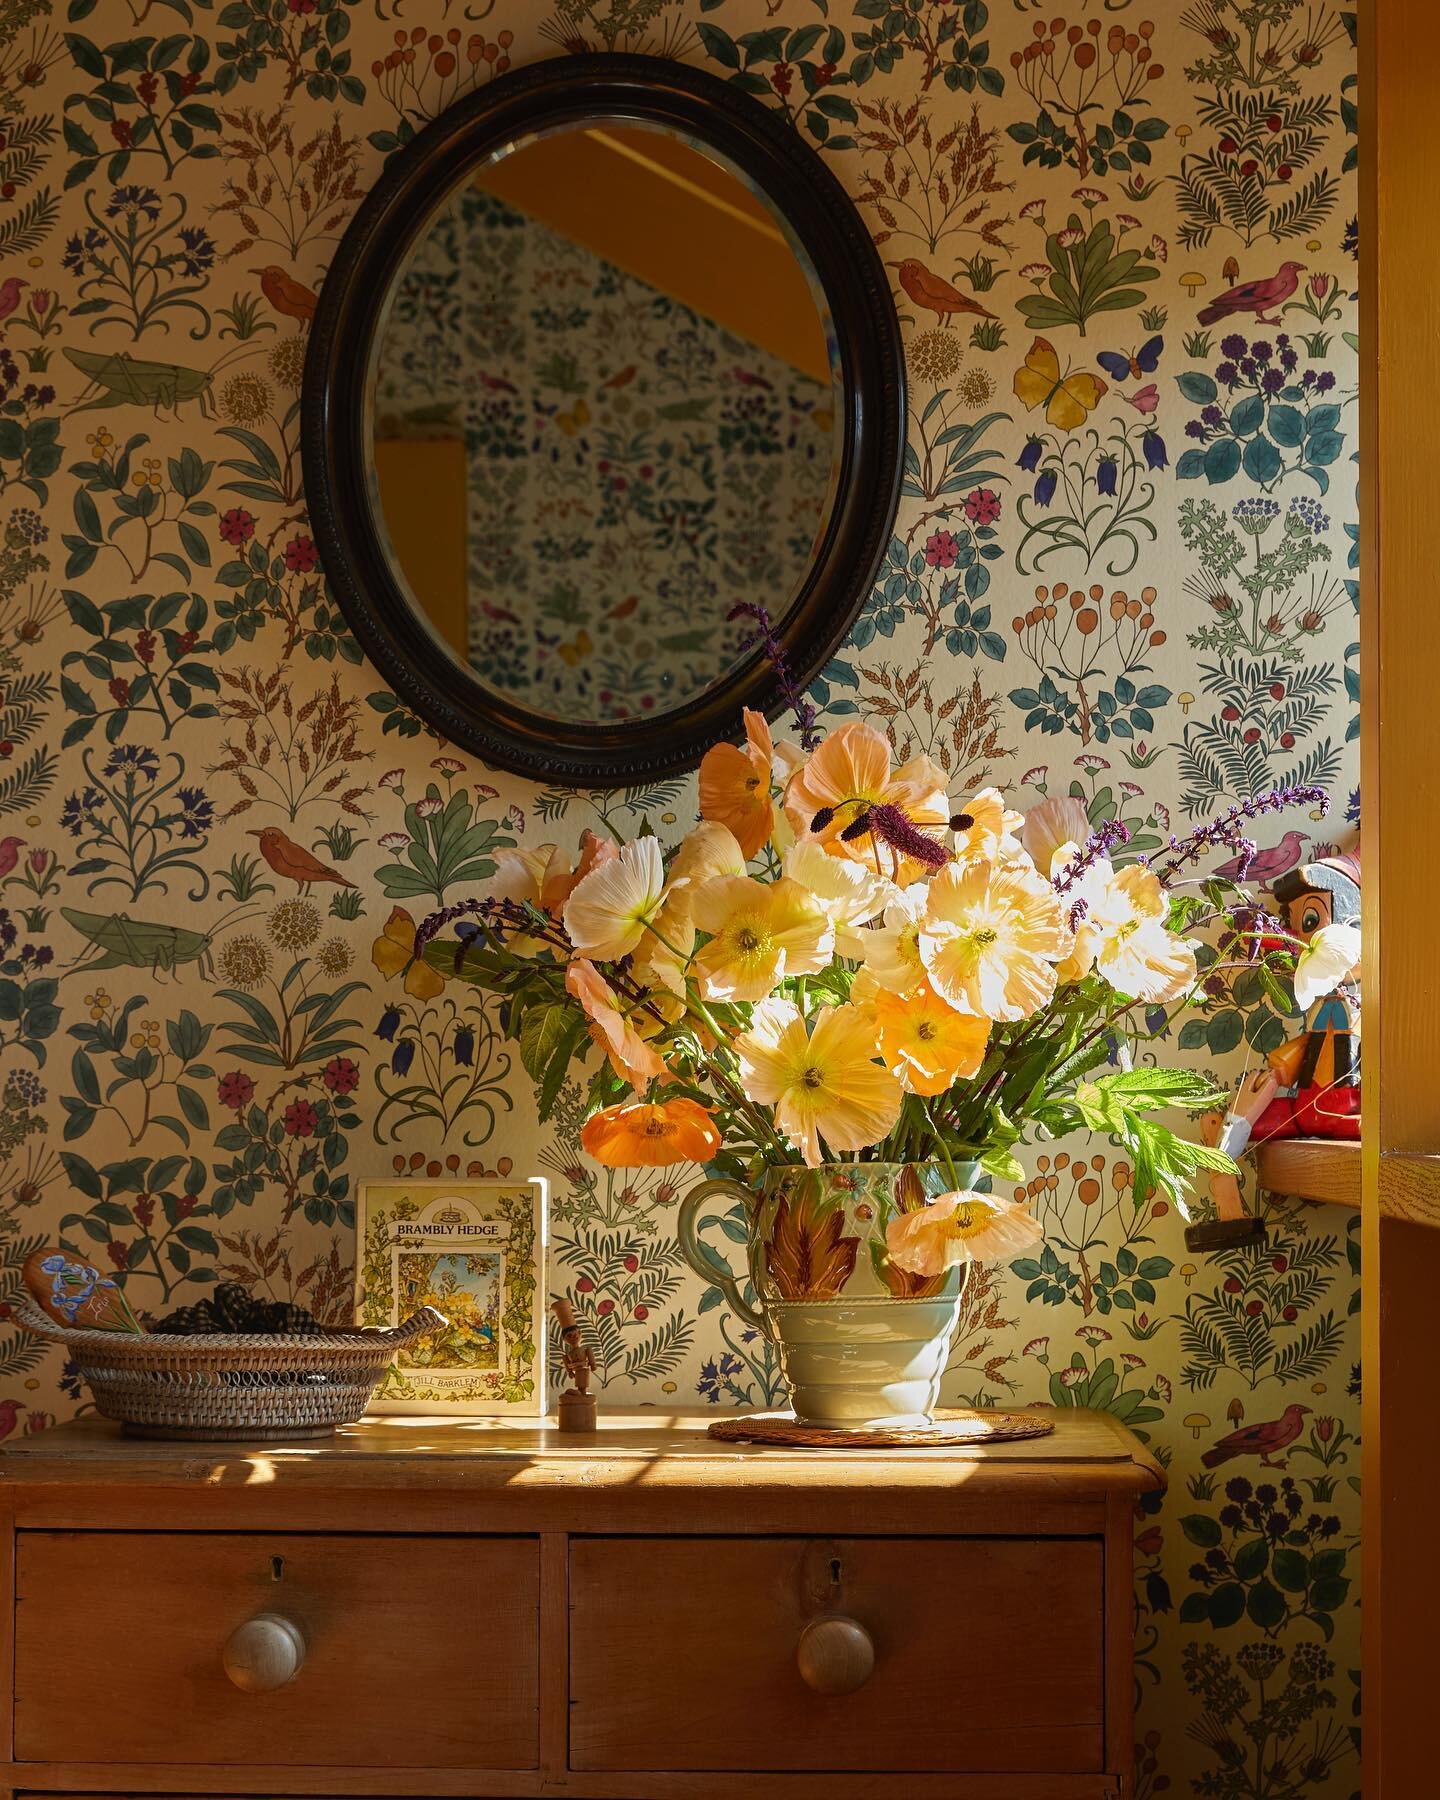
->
785, 724, 950, 882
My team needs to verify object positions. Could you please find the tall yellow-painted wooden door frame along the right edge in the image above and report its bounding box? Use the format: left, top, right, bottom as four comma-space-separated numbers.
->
1359, 0, 1440, 1800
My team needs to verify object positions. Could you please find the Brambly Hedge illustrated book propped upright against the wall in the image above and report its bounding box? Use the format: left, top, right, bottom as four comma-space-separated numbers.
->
356, 1179, 545, 1417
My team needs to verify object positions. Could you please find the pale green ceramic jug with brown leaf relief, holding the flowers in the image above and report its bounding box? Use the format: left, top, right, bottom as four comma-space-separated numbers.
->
677, 1163, 977, 1431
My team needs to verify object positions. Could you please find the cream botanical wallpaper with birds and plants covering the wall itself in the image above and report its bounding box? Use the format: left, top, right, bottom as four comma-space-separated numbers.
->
0, 0, 1359, 1800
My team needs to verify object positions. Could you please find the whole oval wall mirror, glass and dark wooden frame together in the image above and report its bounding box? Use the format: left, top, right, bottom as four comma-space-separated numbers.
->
302, 56, 904, 787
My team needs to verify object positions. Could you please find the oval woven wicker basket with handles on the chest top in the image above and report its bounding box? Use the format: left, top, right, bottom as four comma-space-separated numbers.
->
16, 1305, 446, 1440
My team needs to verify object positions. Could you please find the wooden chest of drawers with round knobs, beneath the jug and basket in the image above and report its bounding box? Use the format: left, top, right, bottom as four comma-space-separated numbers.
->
0, 1413, 1161, 1800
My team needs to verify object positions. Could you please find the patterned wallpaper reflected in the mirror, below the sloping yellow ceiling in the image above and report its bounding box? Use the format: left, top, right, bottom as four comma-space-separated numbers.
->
376, 187, 835, 720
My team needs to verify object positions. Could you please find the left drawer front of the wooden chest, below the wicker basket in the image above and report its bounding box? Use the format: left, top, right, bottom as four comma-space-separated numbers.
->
14, 1532, 540, 1769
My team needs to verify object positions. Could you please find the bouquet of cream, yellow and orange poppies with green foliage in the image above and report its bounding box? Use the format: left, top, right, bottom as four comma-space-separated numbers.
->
376, 662, 1325, 1274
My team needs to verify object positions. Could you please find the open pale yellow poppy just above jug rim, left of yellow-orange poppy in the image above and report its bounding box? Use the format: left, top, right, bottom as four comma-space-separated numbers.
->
734, 999, 904, 1168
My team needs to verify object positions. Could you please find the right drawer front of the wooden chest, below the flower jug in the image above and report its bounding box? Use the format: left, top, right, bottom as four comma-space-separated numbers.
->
571, 1537, 1105, 1775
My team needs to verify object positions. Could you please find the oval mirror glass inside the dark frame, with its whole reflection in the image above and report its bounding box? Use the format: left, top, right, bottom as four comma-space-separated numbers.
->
373, 122, 837, 724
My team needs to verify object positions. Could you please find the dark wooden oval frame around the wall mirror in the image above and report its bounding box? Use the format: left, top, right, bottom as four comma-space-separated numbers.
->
301, 54, 905, 788
